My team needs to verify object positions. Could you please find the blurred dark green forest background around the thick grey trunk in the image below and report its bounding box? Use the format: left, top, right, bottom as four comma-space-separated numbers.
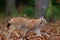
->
0, 0, 60, 21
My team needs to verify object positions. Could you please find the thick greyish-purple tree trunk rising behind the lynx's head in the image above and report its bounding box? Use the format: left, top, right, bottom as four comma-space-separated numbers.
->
35, 0, 50, 18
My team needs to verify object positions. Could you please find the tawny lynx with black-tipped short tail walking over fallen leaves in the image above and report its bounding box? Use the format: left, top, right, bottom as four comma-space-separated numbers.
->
7, 17, 47, 36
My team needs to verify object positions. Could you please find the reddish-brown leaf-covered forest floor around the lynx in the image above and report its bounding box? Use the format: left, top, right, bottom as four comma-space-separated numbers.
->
0, 17, 60, 40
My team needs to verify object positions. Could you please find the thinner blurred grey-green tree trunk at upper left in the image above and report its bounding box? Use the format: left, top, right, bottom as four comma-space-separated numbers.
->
6, 0, 16, 15
